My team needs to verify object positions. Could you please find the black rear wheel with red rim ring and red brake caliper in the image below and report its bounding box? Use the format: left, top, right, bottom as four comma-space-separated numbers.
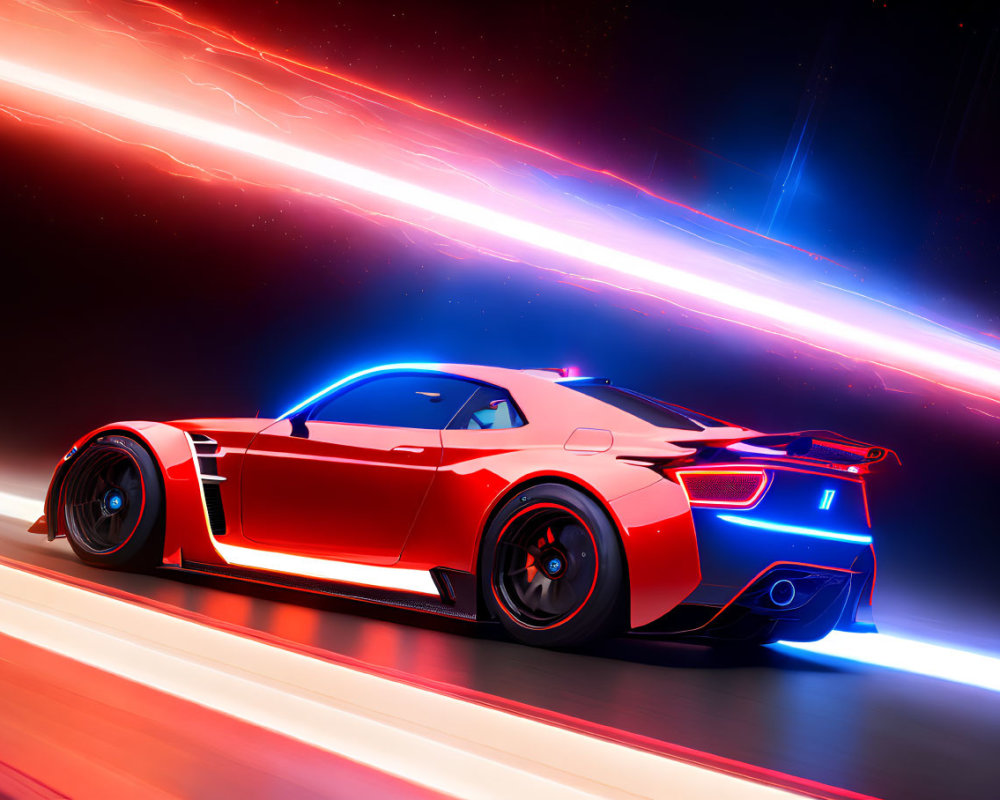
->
480, 483, 625, 647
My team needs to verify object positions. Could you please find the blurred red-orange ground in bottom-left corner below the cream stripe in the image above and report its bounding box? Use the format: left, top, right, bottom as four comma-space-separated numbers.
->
0, 636, 440, 800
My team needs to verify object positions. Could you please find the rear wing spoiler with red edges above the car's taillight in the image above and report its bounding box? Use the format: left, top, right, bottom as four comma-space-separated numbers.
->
727, 431, 900, 472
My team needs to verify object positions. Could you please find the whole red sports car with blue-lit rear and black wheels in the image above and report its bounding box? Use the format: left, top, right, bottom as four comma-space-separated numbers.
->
32, 364, 889, 646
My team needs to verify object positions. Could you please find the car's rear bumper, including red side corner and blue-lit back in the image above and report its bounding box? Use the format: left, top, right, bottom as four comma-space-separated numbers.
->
611, 469, 875, 640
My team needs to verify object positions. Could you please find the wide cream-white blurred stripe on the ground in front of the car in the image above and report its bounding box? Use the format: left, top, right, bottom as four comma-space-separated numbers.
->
0, 566, 798, 800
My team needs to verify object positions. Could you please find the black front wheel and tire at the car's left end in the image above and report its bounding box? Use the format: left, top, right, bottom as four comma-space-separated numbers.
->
59, 435, 163, 570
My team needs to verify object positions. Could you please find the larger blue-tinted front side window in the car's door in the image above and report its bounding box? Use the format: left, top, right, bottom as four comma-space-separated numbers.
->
309, 373, 478, 430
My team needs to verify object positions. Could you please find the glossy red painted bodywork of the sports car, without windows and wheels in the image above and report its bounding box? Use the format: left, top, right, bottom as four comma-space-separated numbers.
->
35, 364, 888, 627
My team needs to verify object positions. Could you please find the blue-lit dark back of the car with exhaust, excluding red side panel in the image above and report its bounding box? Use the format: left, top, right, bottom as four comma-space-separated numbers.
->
647, 465, 875, 641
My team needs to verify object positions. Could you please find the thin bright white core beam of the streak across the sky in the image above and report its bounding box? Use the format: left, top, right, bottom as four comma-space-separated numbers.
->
0, 60, 1000, 398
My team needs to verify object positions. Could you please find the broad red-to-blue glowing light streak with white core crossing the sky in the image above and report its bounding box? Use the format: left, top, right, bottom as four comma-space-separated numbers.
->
0, 0, 1000, 412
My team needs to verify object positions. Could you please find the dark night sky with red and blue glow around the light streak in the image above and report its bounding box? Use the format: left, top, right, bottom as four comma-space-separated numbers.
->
0, 0, 1000, 649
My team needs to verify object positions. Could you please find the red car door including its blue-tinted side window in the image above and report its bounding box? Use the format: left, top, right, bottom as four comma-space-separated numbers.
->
242, 372, 477, 564
